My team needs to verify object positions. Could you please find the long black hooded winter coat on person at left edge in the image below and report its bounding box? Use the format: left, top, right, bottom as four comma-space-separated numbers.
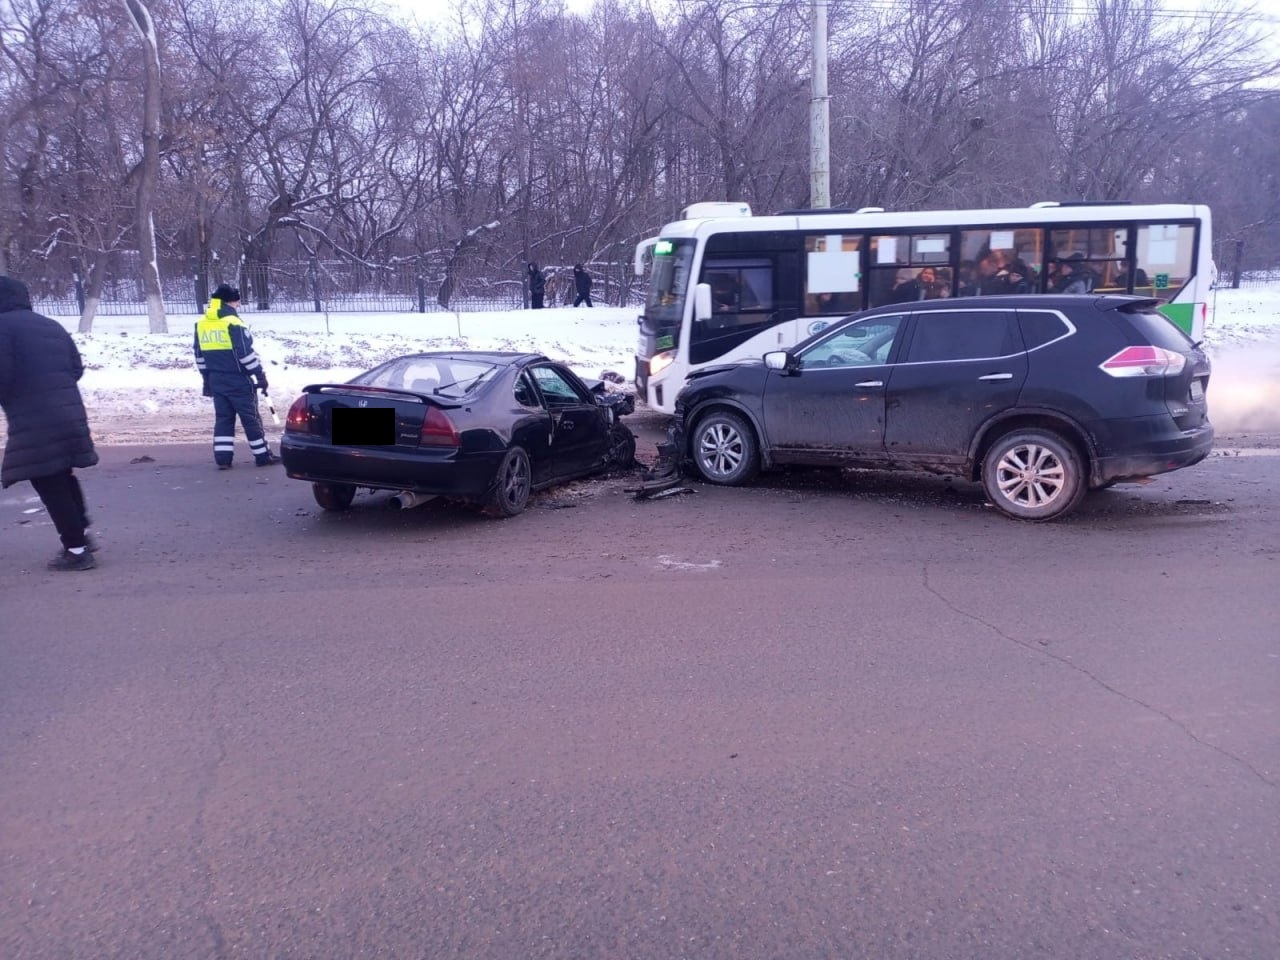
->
0, 276, 97, 486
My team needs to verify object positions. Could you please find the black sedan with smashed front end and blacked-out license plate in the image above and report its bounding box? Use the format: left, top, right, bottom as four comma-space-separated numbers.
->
280, 352, 635, 517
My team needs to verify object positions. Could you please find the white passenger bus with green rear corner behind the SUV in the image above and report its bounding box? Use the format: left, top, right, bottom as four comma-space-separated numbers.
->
635, 202, 1213, 413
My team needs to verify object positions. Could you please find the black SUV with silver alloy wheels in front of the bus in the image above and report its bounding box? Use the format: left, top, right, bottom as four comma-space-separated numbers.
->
673, 296, 1213, 520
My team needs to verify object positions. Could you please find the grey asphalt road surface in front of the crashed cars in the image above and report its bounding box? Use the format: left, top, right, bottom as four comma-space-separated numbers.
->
0, 427, 1280, 960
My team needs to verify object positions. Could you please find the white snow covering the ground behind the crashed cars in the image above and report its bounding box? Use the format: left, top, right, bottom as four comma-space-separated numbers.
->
0, 285, 1280, 444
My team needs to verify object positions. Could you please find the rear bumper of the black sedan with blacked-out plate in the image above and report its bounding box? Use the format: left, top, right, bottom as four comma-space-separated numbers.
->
280, 434, 502, 499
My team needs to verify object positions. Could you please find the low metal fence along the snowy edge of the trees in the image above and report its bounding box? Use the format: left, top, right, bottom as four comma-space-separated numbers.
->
29, 260, 640, 316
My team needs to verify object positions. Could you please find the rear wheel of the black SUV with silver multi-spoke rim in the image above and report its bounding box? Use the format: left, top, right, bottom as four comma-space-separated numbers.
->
982, 430, 1088, 522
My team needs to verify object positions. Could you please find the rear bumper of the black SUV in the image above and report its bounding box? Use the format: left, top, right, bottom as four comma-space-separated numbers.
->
1089, 416, 1213, 484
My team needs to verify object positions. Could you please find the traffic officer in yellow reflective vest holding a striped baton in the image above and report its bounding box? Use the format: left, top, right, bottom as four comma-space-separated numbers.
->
196, 283, 280, 470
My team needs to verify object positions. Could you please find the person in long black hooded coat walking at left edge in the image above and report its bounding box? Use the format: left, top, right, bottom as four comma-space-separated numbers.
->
0, 276, 97, 570
